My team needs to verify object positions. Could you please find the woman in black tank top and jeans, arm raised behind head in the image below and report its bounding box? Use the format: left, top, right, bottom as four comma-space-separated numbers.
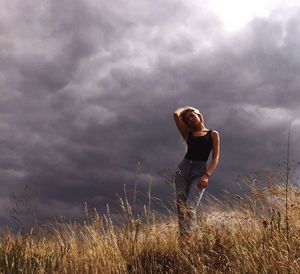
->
173, 106, 220, 240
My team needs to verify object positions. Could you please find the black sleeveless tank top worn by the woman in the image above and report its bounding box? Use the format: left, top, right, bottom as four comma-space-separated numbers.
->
184, 130, 212, 161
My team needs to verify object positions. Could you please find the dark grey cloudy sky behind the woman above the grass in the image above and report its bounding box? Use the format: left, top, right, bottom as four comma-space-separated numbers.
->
0, 0, 300, 231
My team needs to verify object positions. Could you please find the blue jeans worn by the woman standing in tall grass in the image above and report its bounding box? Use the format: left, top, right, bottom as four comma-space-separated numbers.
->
174, 159, 207, 236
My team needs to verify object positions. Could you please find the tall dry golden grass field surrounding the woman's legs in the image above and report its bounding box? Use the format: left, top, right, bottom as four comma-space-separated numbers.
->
0, 176, 300, 274
